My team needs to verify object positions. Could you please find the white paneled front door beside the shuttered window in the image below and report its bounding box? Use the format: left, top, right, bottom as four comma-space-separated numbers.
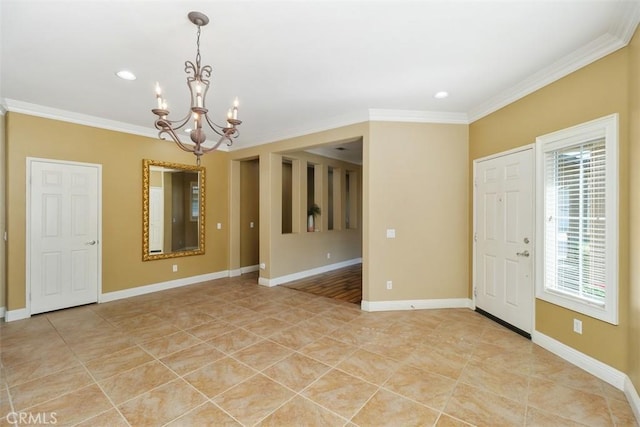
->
474, 149, 534, 333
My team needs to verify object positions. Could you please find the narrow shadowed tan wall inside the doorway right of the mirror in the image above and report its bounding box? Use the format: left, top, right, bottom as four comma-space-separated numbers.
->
240, 159, 260, 267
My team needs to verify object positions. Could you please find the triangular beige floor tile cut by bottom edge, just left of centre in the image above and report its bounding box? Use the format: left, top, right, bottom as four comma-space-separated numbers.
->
258, 396, 347, 427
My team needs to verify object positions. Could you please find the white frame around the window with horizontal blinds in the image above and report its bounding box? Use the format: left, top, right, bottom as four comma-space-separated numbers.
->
536, 113, 620, 325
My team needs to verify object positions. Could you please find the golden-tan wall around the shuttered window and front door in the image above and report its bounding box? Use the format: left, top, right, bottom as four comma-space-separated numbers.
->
468, 49, 630, 372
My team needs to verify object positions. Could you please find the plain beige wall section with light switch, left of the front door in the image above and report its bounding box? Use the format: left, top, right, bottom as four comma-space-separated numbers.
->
364, 122, 469, 301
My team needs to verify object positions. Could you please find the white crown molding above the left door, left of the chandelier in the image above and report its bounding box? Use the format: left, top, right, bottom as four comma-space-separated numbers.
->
5, 99, 158, 138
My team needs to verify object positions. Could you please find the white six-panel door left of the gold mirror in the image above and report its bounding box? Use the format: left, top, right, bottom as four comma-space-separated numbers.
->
27, 159, 101, 314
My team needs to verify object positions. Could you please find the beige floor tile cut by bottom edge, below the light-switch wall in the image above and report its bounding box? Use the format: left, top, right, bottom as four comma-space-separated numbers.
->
351, 390, 440, 427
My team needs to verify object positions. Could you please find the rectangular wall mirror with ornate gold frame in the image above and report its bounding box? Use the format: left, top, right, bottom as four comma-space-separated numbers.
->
142, 159, 205, 261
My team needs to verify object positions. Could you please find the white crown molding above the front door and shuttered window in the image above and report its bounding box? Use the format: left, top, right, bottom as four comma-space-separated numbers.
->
469, 30, 638, 123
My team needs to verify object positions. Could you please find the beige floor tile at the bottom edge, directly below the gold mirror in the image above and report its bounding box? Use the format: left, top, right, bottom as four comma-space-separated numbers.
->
119, 379, 206, 426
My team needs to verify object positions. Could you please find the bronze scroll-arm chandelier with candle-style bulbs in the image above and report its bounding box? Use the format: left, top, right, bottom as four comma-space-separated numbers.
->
151, 12, 242, 166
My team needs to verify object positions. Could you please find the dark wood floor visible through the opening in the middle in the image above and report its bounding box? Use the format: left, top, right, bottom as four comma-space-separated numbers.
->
282, 264, 362, 304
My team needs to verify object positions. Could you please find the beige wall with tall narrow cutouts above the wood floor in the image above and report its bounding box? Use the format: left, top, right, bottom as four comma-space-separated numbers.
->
230, 123, 368, 279
